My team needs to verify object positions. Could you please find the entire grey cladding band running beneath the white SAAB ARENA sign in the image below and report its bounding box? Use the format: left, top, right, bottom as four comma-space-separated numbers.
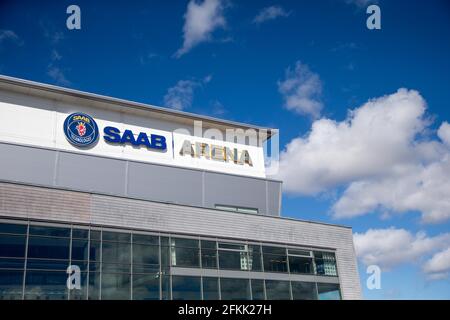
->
0, 143, 281, 216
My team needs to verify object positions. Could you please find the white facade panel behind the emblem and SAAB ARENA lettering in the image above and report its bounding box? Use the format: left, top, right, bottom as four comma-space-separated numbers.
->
0, 91, 265, 178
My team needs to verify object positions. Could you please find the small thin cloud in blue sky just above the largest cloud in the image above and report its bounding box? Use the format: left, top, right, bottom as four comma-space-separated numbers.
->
278, 61, 323, 118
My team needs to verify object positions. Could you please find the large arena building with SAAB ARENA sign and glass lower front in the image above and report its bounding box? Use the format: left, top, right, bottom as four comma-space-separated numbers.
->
0, 76, 361, 299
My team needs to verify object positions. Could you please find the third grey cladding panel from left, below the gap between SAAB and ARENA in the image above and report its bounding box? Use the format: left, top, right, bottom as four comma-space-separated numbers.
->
128, 162, 203, 206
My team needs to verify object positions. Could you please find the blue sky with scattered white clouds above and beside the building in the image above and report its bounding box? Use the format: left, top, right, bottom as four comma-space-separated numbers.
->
0, 0, 450, 299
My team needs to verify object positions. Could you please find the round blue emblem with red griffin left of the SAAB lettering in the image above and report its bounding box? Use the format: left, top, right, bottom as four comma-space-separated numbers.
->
64, 112, 98, 147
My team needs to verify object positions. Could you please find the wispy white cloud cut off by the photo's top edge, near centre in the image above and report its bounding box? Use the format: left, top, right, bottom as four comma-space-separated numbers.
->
175, 0, 226, 58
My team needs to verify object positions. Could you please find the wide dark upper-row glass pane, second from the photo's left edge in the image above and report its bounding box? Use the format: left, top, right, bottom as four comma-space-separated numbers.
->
28, 236, 70, 259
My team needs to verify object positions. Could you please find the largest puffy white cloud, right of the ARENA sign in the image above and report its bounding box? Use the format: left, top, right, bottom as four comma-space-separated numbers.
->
277, 89, 450, 223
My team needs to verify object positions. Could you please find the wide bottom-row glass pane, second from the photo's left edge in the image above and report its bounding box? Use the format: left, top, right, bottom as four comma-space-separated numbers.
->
25, 271, 68, 300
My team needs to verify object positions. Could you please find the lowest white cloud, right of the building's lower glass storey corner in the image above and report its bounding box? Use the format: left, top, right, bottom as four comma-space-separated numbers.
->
353, 228, 450, 273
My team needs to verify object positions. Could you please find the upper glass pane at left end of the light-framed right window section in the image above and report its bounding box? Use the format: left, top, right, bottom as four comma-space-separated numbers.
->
171, 238, 200, 268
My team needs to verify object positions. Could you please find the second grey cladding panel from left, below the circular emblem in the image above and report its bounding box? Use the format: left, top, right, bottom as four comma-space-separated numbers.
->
57, 152, 126, 196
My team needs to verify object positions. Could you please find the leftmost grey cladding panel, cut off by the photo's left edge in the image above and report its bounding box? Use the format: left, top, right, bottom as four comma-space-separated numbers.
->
0, 144, 55, 186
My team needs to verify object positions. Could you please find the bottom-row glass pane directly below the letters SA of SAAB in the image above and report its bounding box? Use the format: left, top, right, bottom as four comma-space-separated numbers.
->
101, 272, 131, 300
